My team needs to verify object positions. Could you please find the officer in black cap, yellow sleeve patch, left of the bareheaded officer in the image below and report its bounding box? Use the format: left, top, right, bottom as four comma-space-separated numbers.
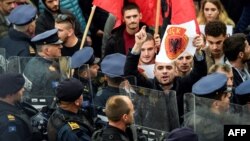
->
48, 78, 93, 141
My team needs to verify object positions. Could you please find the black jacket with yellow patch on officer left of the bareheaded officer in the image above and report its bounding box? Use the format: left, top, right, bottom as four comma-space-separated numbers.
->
48, 108, 93, 141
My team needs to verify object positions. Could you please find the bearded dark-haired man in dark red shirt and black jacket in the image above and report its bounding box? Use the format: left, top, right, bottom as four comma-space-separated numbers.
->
104, 3, 150, 56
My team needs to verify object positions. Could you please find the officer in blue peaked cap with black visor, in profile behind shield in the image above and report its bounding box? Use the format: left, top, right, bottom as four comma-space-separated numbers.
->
23, 29, 63, 96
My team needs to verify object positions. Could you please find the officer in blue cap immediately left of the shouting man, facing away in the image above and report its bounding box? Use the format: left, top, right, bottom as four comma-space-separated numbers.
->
94, 53, 126, 107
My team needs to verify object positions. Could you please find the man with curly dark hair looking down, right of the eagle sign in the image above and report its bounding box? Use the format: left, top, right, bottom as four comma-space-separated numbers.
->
205, 21, 227, 69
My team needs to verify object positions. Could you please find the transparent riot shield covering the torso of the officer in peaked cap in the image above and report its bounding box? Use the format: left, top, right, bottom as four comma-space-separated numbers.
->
7, 56, 65, 108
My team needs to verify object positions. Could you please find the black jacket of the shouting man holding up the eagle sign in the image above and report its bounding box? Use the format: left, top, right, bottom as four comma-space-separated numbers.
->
124, 53, 207, 122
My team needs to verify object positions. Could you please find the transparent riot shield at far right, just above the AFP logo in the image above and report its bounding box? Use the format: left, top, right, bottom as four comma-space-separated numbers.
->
184, 93, 250, 141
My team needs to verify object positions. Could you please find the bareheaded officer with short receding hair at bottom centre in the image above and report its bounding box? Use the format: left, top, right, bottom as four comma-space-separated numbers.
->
102, 95, 134, 141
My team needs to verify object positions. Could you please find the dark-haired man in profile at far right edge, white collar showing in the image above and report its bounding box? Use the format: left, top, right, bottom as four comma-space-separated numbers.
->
223, 33, 250, 87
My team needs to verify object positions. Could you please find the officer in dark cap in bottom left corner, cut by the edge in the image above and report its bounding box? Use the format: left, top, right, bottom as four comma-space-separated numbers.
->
0, 73, 32, 141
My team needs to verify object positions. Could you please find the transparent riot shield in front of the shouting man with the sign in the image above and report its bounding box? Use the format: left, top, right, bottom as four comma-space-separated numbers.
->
120, 86, 179, 140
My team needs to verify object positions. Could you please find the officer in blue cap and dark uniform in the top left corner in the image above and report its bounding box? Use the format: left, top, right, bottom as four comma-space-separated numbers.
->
0, 5, 37, 58
